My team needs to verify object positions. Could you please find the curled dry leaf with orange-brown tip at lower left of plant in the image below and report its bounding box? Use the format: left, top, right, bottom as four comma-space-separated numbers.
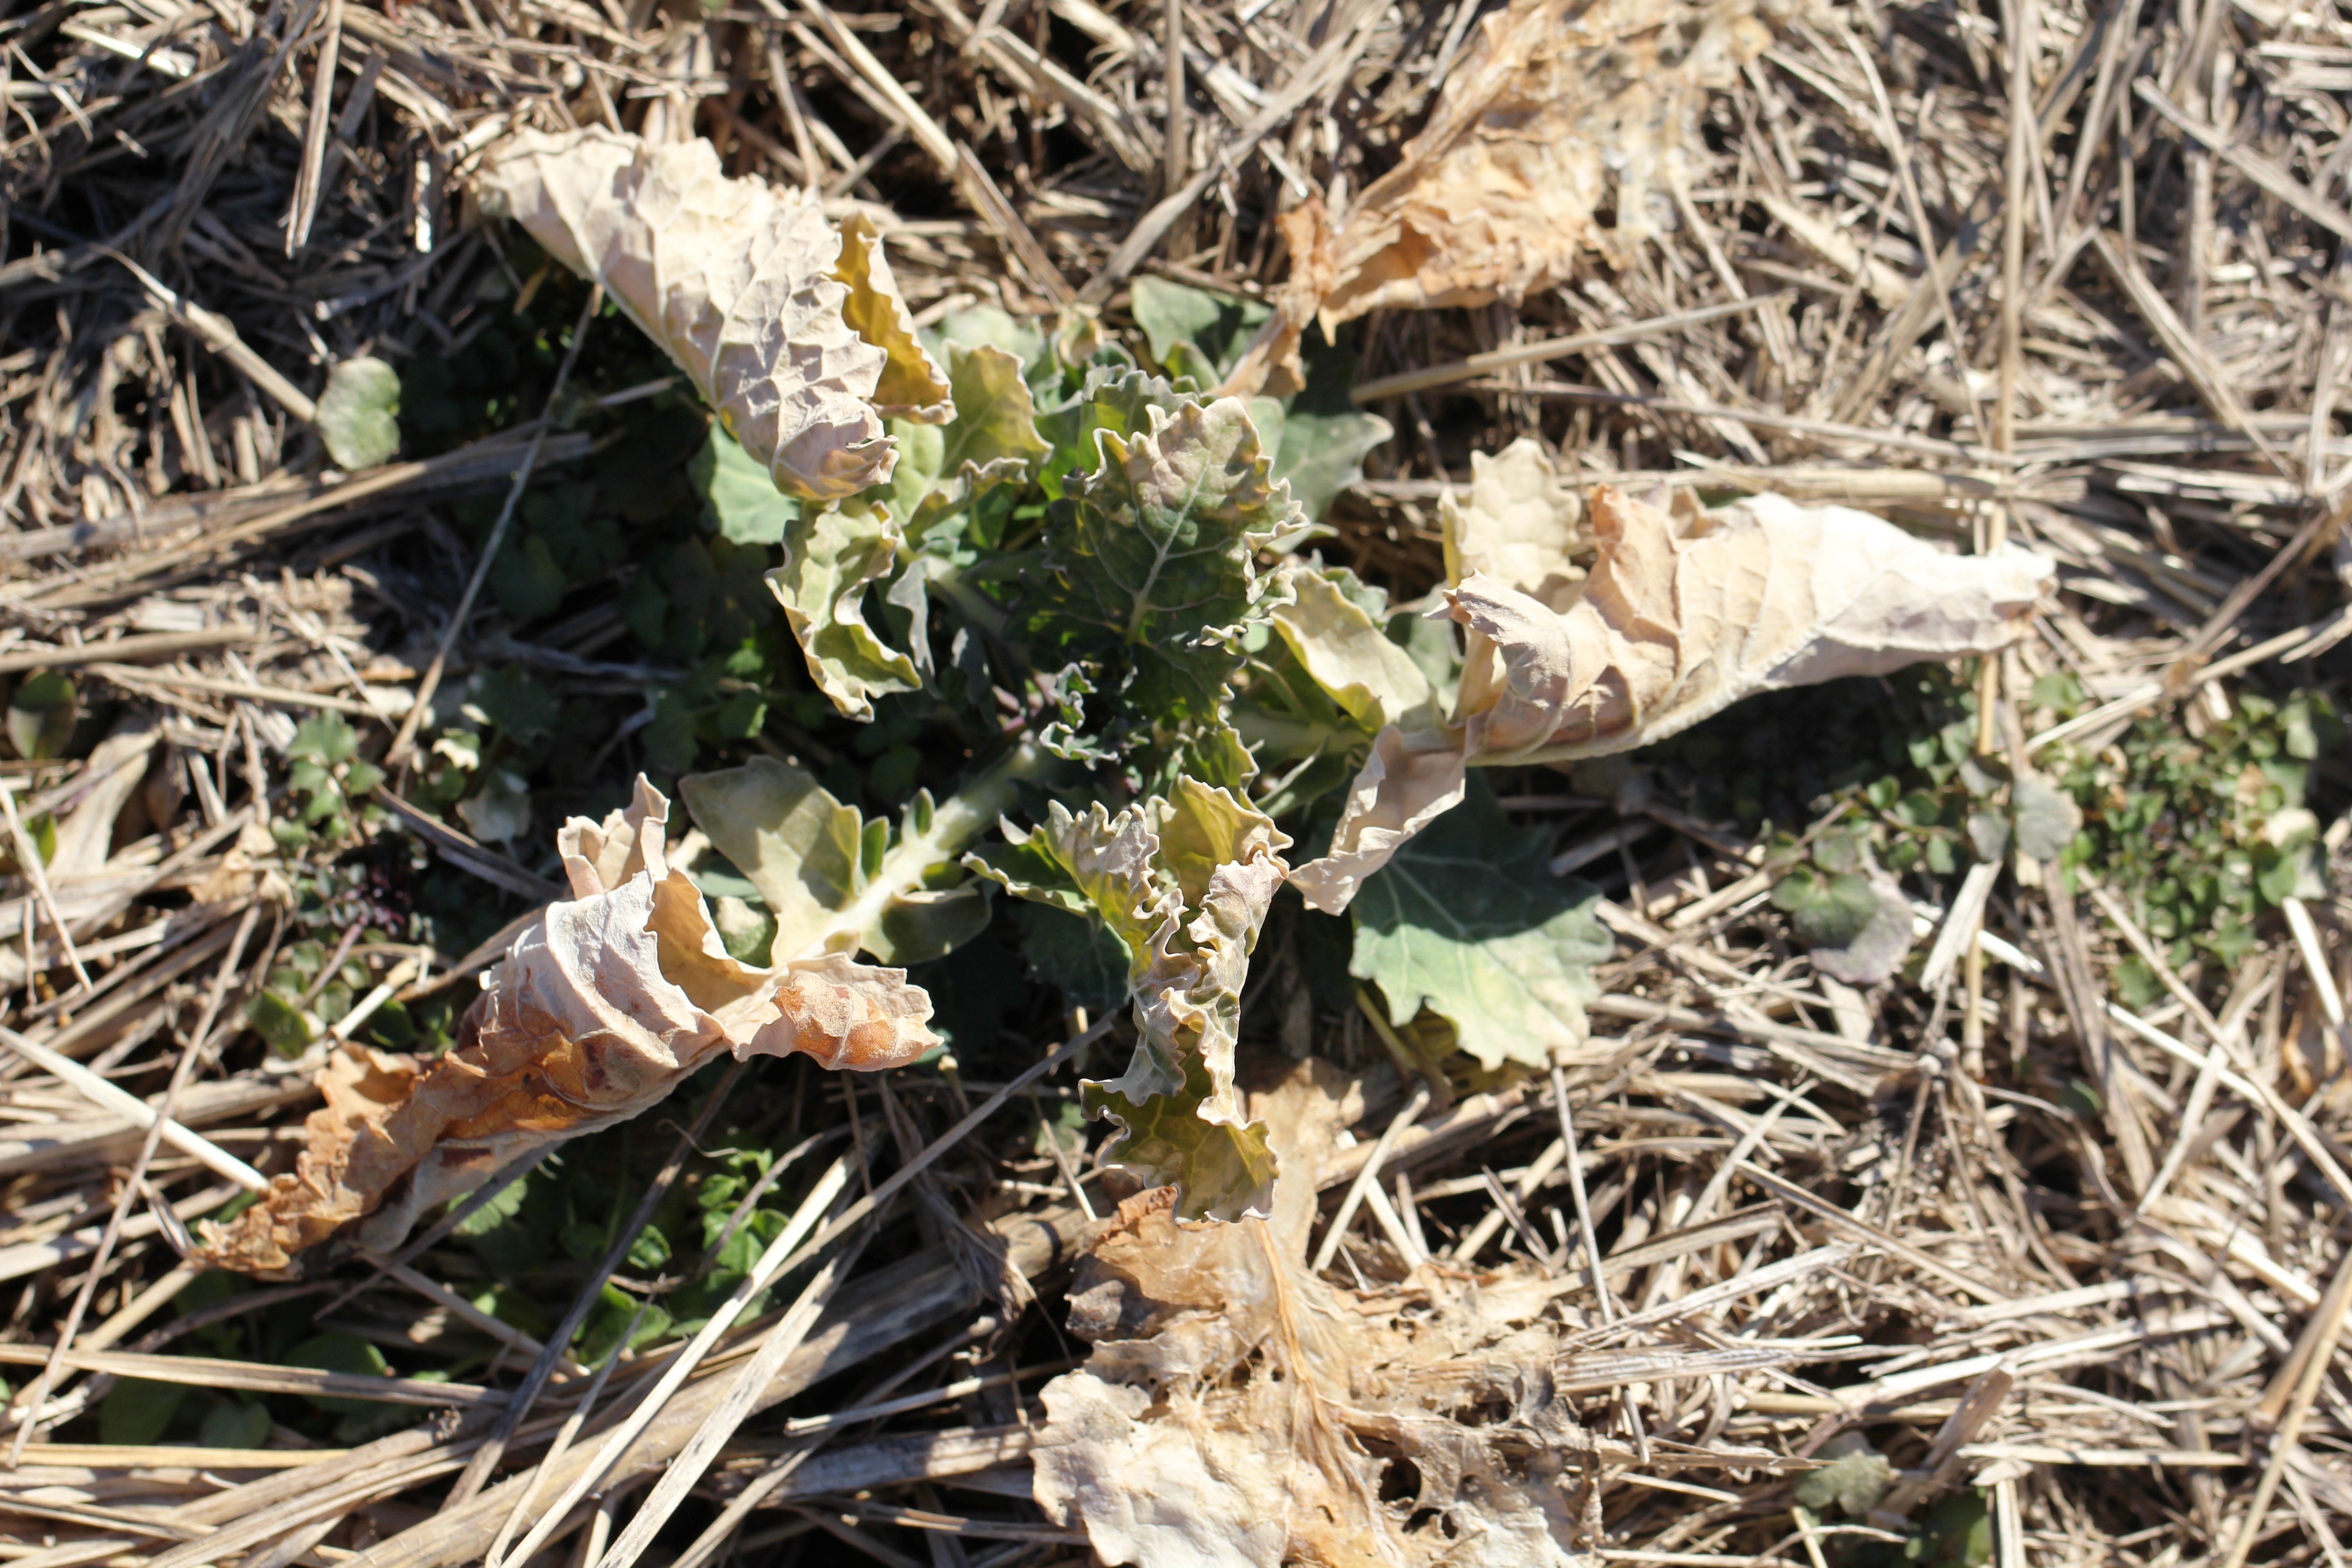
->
202, 778, 938, 1277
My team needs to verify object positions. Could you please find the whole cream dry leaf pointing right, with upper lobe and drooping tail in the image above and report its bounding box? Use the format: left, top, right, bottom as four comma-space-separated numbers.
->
1291, 461, 2051, 915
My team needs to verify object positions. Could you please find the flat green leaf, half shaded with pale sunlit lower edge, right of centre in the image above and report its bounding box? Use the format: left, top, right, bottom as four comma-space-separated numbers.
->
1348, 783, 1611, 1067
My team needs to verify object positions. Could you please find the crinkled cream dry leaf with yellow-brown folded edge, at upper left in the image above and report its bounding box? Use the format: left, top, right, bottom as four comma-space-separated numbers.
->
477, 127, 955, 501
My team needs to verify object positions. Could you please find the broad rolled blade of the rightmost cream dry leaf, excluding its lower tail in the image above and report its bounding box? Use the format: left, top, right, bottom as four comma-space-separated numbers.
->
1446, 484, 2051, 764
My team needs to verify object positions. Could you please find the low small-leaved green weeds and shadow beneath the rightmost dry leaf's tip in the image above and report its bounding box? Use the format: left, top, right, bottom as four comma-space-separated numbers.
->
1644, 668, 2342, 982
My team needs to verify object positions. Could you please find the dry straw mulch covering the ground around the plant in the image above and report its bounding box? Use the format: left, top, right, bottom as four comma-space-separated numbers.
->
0, 0, 2352, 1568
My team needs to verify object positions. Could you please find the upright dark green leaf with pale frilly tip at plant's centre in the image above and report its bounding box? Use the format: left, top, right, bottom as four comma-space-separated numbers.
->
1033, 397, 1298, 722
